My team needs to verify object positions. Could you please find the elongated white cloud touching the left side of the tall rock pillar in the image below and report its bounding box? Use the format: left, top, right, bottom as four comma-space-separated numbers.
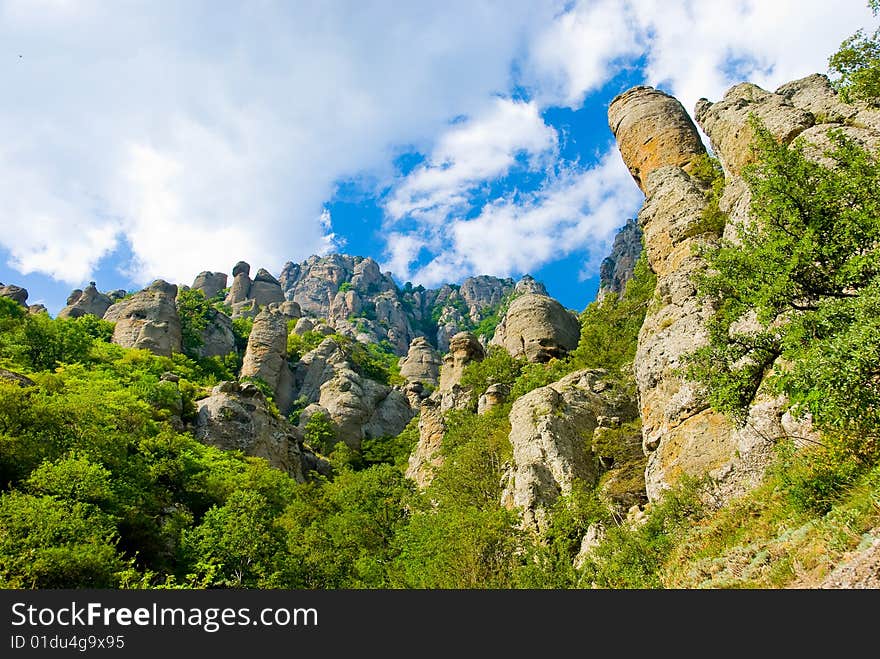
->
388, 150, 643, 286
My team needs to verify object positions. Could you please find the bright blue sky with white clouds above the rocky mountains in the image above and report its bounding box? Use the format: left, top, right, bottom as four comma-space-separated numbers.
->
0, 0, 874, 314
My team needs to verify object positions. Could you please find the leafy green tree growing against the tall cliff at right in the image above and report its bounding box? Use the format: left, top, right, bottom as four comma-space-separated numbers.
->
688, 121, 880, 457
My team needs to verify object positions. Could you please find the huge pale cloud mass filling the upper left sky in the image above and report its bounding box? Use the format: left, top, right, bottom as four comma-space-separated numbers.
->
0, 0, 557, 284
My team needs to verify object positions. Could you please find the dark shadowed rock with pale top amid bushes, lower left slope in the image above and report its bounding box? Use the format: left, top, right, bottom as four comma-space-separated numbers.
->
193, 382, 305, 482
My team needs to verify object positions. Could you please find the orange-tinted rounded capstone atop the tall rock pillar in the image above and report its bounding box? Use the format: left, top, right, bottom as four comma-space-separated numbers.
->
608, 86, 706, 193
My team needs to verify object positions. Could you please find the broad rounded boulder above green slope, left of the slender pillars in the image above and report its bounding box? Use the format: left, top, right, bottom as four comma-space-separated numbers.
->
104, 279, 181, 357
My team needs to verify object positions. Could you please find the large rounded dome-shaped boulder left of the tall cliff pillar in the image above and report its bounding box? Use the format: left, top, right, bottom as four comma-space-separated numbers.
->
490, 293, 580, 362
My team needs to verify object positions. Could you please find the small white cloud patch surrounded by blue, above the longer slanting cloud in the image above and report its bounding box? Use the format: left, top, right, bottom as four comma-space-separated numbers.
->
385, 98, 557, 226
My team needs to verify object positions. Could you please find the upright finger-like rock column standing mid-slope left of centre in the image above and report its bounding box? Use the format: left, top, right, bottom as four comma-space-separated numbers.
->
241, 306, 293, 414
